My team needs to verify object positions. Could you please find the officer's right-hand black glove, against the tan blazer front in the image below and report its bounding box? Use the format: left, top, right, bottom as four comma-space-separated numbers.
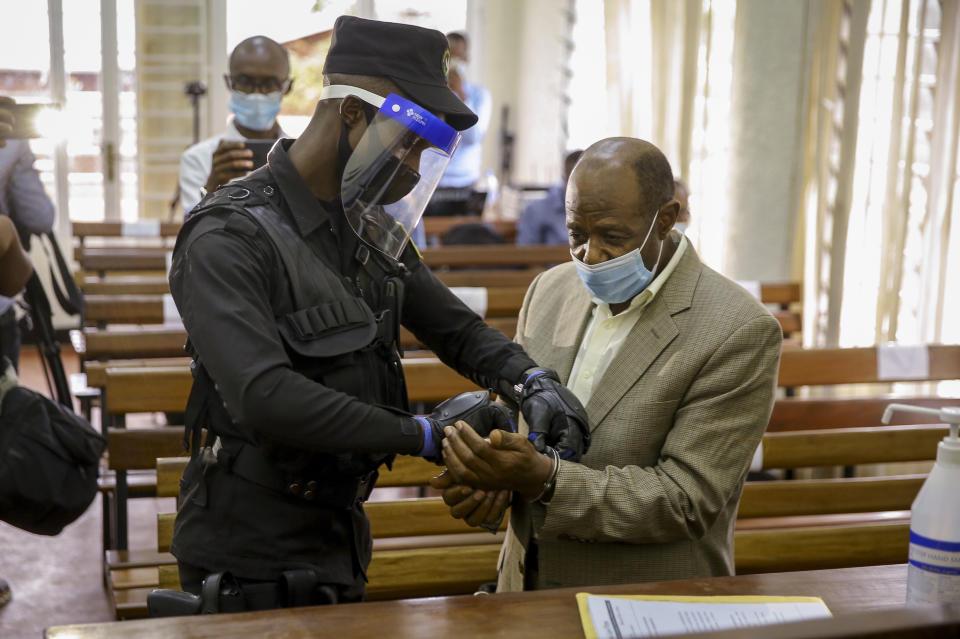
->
518, 368, 590, 462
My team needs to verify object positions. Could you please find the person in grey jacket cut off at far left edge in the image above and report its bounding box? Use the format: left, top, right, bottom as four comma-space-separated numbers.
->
0, 96, 56, 368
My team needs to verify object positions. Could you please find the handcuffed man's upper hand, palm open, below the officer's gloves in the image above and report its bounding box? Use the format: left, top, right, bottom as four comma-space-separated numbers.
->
443, 424, 553, 500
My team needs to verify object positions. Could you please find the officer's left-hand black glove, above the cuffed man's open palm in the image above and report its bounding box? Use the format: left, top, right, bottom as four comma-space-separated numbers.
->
415, 390, 517, 464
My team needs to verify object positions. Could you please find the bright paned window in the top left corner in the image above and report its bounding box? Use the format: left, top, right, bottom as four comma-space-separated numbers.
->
0, 0, 138, 225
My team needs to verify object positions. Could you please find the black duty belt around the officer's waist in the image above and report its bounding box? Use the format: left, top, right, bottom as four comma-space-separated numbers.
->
212, 437, 378, 509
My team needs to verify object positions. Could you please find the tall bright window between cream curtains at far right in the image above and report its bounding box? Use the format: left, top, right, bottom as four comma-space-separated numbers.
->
834, 0, 940, 346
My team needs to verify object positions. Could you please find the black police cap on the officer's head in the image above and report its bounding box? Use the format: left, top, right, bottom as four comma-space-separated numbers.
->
323, 16, 477, 131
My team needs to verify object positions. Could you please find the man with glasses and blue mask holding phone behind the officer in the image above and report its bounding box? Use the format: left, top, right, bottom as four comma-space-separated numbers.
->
180, 36, 293, 213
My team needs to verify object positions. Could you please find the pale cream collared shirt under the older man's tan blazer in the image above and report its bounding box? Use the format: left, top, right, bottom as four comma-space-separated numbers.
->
567, 234, 687, 406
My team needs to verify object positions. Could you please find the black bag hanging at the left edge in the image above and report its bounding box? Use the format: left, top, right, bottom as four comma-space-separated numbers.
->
0, 380, 107, 535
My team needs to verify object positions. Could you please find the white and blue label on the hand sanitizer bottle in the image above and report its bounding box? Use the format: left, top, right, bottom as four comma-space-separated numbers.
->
907, 530, 960, 604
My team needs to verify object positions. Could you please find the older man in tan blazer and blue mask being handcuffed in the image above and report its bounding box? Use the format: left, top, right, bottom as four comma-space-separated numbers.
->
434, 138, 781, 590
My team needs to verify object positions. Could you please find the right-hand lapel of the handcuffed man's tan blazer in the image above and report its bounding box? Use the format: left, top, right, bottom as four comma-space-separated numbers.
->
587, 244, 702, 430
